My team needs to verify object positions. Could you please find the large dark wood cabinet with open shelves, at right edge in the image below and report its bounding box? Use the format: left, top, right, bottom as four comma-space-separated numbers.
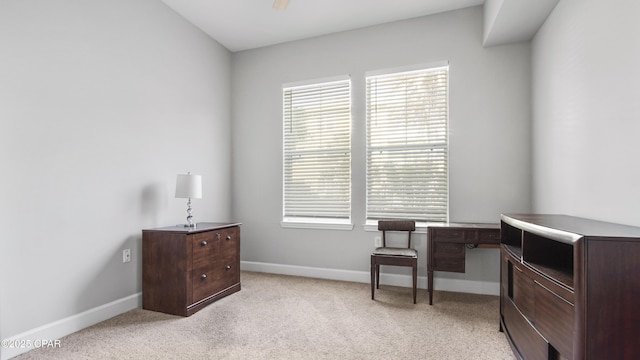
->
500, 215, 640, 360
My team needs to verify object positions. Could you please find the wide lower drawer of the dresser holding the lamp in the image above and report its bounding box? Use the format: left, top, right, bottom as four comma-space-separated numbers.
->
191, 256, 240, 302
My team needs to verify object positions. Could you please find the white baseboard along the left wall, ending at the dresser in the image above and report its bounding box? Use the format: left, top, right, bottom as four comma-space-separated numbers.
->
0, 292, 142, 360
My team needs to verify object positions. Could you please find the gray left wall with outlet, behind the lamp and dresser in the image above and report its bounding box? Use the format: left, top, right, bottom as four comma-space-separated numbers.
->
0, 0, 231, 348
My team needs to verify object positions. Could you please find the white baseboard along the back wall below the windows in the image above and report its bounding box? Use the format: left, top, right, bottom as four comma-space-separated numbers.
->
240, 261, 500, 295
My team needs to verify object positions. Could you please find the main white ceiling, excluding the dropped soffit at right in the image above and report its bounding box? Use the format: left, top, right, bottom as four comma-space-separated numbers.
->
162, 0, 484, 52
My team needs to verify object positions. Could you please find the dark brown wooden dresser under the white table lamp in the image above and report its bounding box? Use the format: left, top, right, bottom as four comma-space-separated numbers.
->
142, 223, 240, 316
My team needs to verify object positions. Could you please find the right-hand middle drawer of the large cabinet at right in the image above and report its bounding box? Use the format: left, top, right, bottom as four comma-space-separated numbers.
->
535, 281, 574, 359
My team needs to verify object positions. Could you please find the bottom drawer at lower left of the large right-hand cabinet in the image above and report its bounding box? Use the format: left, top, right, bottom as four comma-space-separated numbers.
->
503, 299, 549, 360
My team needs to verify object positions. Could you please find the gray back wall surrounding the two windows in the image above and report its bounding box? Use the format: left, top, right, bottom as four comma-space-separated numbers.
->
231, 7, 531, 293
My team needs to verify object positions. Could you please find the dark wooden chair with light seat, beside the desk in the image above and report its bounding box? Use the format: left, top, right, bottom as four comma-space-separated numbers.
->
371, 220, 418, 304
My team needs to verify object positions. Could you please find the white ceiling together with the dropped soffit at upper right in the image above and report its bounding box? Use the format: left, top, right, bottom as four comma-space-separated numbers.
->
162, 0, 558, 52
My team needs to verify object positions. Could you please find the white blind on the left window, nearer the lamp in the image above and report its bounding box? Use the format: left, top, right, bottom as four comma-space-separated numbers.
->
283, 78, 351, 222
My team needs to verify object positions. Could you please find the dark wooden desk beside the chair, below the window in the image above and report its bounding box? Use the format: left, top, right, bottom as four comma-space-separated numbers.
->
427, 223, 500, 305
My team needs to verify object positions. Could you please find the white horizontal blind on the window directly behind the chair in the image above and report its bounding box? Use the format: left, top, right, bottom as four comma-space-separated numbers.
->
366, 66, 449, 222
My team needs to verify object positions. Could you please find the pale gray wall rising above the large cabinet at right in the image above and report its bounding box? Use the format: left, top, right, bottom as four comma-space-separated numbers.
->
532, 0, 640, 226
